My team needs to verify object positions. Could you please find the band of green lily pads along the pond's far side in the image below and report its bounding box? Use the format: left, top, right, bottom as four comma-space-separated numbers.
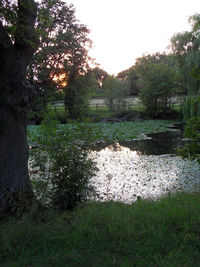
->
28, 120, 172, 145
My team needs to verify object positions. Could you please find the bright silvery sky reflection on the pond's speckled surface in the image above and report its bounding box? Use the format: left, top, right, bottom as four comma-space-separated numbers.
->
91, 140, 200, 203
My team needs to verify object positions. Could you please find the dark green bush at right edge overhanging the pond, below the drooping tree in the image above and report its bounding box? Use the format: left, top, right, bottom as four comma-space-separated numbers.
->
179, 117, 200, 162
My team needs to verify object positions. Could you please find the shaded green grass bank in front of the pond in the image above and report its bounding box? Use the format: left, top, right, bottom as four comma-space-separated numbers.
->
0, 194, 200, 267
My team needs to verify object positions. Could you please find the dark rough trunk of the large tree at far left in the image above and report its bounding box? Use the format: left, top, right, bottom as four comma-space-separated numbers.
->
0, 0, 37, 217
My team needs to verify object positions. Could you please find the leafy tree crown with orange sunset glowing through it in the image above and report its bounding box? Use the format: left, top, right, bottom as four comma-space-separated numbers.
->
28, 0, 91, 117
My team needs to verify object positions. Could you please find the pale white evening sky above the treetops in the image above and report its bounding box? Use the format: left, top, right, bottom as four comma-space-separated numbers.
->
67, 0, 200, 75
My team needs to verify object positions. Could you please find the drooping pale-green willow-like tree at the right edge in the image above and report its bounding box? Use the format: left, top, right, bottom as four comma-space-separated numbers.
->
171, 14, 200, 120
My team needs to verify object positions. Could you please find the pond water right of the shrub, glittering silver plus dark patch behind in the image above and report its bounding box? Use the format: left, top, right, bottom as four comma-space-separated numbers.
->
91, 126, 200, 204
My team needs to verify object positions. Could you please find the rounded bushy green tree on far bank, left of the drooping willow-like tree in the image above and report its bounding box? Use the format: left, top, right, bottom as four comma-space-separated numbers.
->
135, 54, 178, 115
